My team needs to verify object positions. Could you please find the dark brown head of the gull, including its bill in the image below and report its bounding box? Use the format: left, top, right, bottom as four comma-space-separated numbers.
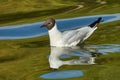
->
41, 18, 55, 30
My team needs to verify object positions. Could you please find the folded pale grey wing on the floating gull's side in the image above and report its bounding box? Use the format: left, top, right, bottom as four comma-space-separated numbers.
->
63, 26, 97, 45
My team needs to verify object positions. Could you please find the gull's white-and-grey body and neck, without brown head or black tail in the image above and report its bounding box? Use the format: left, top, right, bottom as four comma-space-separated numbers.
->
48, 24, 97, 47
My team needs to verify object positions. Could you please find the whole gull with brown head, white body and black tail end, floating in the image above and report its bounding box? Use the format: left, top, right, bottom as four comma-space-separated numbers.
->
41, 17, 102, 47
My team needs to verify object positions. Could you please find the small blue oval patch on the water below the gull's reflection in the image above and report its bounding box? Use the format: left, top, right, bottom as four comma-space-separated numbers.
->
39, 70, 83, 79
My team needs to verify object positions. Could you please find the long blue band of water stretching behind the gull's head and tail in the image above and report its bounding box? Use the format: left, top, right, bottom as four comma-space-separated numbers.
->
0, 14, 120, 40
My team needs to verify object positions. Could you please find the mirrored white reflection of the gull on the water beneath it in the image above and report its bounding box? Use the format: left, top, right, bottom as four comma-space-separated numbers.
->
49, 47, 99, 69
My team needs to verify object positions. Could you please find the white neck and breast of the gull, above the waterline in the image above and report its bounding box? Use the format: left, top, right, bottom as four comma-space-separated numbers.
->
48, 24, 62, 46
